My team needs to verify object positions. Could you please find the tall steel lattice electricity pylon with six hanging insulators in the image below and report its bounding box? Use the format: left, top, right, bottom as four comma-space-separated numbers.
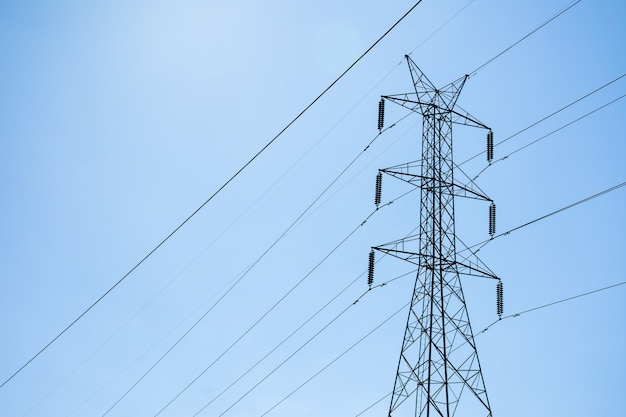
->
368, 56, 502, 417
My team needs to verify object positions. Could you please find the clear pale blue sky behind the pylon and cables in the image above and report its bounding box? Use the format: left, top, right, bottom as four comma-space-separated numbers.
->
0, 0, 626, 417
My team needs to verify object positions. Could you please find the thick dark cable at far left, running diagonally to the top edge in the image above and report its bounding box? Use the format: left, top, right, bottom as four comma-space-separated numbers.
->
0, 0, 422, 388
